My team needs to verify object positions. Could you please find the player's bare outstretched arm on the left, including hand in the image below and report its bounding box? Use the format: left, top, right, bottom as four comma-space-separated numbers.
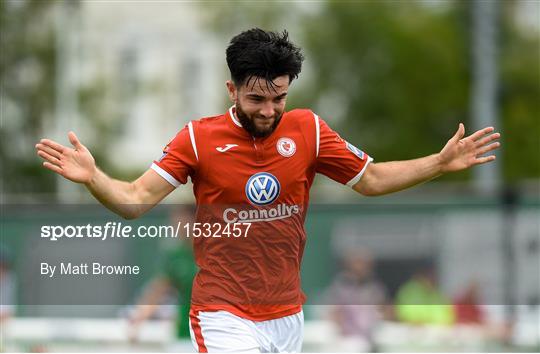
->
36, 132, 174, 219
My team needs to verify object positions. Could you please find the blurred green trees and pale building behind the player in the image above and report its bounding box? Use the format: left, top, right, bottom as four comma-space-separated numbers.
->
0, 0, 540, 198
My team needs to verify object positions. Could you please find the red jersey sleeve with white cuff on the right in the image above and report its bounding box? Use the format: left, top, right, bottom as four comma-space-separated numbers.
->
315, 116, 373, 187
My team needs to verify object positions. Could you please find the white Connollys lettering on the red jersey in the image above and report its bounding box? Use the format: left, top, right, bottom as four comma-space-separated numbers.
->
223, 203, 300, 224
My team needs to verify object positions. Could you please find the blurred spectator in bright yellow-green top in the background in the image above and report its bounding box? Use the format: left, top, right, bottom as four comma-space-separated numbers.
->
395, 266, 454, 325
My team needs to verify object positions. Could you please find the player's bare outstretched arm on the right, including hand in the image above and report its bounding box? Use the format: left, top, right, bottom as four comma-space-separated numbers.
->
353, 123, 500, 196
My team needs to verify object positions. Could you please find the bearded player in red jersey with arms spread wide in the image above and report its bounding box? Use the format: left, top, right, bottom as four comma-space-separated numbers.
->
36, 28, 499, 352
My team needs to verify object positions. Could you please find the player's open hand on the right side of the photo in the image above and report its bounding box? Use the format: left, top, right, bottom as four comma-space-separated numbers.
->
439, 123, 501, 173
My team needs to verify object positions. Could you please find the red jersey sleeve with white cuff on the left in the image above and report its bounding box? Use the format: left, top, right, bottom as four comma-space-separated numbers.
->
150, 126, 197, 187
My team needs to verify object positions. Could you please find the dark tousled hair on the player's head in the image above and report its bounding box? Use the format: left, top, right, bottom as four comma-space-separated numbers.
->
226, 28, 304, 87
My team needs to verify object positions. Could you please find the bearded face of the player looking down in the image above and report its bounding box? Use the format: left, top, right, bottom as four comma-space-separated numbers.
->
227, 75, 289, 137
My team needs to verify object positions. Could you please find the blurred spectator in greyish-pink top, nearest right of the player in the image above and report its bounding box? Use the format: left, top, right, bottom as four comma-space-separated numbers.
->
326, 249, 387, 351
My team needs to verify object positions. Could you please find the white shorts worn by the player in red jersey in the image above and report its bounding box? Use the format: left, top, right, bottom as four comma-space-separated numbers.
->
189, 311, 304, 353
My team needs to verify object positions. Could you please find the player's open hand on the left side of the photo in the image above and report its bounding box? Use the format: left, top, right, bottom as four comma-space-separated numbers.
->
36, 132, 96, 183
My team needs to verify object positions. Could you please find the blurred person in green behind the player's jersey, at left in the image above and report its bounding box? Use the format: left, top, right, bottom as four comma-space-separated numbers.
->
130, 207, 197, 352
